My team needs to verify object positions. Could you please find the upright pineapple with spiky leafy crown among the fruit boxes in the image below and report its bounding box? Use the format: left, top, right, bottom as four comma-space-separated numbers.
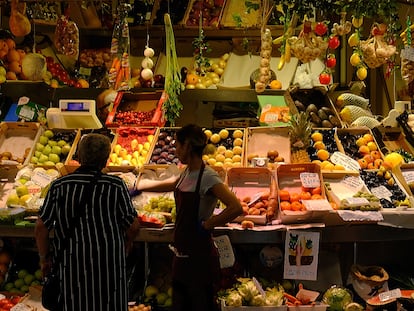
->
289, 111, 312, 163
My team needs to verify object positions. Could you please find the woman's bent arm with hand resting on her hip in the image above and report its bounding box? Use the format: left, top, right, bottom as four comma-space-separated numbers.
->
203, 183, 243, 230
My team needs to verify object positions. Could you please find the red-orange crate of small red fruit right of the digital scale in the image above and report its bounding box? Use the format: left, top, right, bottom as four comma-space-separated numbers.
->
105, 91, 166, 128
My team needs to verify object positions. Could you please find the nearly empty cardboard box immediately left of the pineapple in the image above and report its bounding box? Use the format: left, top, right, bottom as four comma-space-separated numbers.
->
244, 126, 291, 169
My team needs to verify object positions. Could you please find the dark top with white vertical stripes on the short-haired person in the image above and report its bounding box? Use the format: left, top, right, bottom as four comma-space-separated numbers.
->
40, 171, 136, 311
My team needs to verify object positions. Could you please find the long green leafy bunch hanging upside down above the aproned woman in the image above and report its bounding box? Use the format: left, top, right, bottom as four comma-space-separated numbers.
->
163, 14, 184, 126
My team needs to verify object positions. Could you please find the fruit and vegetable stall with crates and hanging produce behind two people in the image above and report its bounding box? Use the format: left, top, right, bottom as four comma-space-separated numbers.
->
0, 0, 414, 311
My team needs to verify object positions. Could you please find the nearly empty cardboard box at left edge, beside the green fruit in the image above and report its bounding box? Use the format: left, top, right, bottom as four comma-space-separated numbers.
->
0, 122, 40, 165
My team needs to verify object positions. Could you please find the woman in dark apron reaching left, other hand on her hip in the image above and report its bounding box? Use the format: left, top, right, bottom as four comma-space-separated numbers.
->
139, 124, 243, 311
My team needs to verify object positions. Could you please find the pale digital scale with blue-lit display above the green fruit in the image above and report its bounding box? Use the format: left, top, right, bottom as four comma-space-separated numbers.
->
46, 99, 102, 129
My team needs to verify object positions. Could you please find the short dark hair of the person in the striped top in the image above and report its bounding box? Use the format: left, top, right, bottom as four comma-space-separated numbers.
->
78, 133, 111, 169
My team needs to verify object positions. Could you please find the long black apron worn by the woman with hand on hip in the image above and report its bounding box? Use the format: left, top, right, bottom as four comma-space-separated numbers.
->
172, 164, 220, 285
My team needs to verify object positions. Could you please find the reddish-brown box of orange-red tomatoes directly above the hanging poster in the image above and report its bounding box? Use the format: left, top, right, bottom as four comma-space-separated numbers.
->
276, 163, 332, 224
